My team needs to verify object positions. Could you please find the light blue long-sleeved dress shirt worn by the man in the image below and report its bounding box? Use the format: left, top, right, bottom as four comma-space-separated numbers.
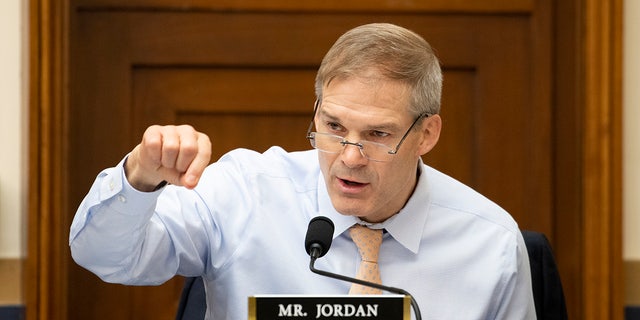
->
69, 147, 535, 320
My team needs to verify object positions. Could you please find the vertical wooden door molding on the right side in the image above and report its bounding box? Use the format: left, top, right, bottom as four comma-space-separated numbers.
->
582, 0, 624, 319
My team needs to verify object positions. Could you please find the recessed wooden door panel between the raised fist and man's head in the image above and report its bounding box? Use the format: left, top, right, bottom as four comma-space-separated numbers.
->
132, 68, 315, 161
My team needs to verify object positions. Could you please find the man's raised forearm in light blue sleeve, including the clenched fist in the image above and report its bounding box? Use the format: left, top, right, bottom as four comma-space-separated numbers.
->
69, 125, 211, 285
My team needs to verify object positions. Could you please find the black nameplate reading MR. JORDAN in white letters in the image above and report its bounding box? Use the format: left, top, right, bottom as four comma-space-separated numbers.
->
249, 295, 411, 320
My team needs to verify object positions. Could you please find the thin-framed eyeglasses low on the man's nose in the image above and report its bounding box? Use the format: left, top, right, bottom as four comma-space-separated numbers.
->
307, 101, 431, 162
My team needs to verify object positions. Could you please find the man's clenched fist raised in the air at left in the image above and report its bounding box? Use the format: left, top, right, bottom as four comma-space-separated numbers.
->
125, 125, 211, 192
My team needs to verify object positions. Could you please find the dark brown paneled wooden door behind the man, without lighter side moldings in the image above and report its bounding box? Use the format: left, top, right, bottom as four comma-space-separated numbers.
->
26, 0, 624, 319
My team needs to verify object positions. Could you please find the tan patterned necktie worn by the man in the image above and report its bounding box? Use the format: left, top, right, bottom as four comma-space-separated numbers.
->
349, 224, 382, 294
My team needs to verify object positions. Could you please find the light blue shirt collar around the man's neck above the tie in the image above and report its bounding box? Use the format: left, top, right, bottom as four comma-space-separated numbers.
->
318, 160, 430, 253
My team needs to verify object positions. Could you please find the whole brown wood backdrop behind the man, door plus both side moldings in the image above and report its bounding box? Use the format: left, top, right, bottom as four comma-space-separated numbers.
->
25, 0, 622, 319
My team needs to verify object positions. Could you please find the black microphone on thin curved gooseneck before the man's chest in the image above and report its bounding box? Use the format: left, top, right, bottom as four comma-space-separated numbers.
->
304, 216, 422, 320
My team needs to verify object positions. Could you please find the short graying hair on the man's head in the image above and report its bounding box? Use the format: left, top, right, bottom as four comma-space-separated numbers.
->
315, 23, 442, 116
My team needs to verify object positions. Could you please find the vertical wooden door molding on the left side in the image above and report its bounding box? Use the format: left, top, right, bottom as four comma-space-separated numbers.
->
24, 0, 69, 320
